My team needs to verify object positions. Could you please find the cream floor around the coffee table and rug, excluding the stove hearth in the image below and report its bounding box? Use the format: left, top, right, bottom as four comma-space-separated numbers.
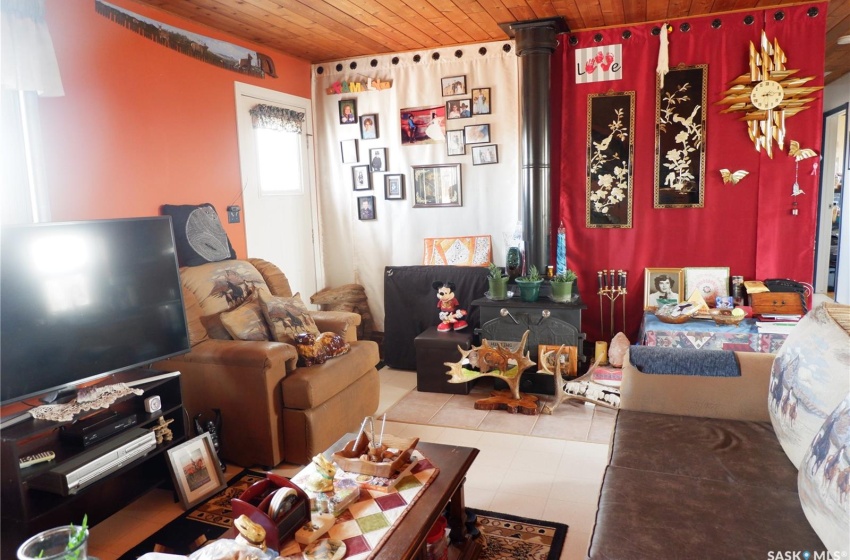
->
89, 368, 613, 560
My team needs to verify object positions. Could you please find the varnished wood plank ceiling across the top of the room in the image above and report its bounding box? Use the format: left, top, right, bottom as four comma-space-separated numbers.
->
136, 0, 850, 83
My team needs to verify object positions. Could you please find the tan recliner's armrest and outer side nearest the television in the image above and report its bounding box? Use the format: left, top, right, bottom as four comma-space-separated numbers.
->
154, 340, 298, 467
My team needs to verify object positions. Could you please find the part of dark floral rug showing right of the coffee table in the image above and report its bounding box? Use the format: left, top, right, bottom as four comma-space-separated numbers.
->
468, 508, 568, 560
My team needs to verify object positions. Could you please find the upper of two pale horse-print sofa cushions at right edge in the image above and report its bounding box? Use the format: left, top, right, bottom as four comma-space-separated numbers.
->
767, 304, 850, 469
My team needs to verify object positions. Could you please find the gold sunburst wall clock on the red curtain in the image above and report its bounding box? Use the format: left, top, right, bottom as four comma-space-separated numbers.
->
717, 31, 823, 158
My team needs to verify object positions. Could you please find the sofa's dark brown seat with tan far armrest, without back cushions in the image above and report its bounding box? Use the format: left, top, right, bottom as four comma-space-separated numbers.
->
589, 352, 825, 560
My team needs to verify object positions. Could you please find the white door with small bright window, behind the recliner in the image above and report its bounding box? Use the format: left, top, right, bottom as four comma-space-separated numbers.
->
236, 82, 324, 305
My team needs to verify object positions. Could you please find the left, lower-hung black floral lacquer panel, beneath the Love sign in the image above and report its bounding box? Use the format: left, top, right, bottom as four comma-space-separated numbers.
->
585, 91, 635, 228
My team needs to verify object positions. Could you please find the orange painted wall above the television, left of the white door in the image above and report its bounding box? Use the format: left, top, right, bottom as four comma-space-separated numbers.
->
40, 0, 310, 257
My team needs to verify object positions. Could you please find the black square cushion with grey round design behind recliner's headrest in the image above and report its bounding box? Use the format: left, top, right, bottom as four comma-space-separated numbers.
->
161, 202, 236, 266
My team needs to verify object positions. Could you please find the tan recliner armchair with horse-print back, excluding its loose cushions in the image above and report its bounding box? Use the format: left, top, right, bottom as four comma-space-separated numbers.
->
154, 259, 380, 467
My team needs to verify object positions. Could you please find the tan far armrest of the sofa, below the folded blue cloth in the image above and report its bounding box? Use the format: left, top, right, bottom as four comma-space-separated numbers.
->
620, 352, 775, 422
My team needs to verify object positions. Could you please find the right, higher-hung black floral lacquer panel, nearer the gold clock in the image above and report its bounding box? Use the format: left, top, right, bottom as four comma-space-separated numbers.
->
654, 64, 708, 208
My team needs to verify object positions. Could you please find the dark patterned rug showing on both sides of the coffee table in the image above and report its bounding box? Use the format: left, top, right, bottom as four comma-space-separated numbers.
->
119, 469, 567, 560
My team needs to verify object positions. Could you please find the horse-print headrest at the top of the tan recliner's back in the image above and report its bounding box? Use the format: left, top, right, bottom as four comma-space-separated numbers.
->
180, 260, 266, 318
